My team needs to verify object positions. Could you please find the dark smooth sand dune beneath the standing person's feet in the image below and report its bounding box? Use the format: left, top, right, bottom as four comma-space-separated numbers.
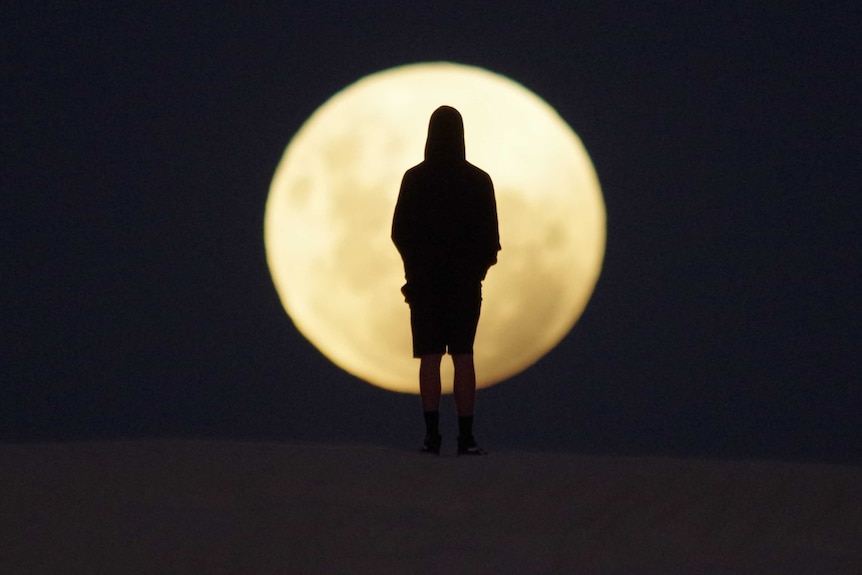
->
0, 440, 862, 575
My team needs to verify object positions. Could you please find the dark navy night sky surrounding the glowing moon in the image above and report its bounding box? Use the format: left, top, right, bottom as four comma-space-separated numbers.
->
0, 2, 862, 462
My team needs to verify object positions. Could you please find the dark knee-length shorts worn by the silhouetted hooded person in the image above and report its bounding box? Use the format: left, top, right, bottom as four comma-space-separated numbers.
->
410, 284, 482, 357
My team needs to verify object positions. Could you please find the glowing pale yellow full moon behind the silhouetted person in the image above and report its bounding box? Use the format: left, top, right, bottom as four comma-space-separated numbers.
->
264, 62, 606, 393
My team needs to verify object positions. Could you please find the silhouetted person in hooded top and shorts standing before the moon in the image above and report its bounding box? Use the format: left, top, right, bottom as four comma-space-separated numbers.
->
392, 106, 500, 455
